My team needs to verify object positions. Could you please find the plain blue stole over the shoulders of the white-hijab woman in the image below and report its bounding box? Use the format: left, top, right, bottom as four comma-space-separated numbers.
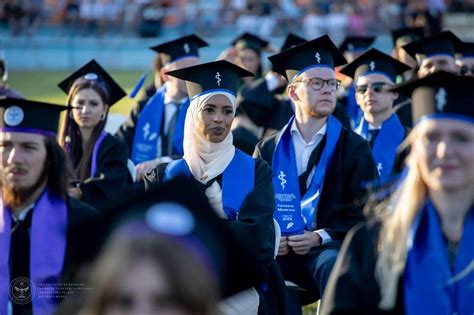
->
163, 149, 255, 220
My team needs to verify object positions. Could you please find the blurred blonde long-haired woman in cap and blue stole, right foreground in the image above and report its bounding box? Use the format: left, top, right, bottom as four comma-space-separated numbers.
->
320, 71, 474, 315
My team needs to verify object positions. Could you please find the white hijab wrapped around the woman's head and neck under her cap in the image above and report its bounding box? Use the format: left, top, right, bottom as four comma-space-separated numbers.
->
183, 91, 236, 218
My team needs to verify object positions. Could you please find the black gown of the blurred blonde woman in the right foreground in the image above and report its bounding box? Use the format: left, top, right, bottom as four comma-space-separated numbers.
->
320, 220, 404, 315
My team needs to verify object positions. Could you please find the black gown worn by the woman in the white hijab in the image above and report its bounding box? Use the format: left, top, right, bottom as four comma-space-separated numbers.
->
145, 159, 285, 314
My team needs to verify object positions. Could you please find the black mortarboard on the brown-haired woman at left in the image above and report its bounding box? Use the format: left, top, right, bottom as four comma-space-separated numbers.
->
58, 59, 127, 106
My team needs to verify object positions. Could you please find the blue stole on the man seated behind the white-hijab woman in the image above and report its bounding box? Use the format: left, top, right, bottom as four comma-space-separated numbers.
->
132, 85, 189, 164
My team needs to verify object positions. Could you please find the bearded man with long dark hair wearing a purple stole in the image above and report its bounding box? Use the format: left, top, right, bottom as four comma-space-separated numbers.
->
0, 98, 100, 315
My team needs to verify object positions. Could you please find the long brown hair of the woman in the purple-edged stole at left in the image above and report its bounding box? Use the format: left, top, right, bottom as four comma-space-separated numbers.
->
59, 77, 110, 181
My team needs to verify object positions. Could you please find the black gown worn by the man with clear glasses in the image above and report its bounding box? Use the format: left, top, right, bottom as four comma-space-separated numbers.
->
254, 127, 377, 243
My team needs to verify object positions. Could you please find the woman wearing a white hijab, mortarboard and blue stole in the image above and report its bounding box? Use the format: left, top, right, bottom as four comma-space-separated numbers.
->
145, 60, 283, 314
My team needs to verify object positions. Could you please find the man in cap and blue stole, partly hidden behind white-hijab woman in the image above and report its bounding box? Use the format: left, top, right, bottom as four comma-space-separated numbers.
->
117, 34, 207, 180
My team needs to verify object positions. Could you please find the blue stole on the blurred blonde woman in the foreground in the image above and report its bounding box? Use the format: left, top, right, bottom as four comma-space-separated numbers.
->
403, 202, 474, 315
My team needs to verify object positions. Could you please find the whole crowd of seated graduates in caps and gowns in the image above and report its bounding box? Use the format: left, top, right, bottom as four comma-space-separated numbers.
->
0, 24, 474, 315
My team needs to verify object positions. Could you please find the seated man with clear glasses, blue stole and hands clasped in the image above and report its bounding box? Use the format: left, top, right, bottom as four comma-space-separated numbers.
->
254, 35, 377, 305
